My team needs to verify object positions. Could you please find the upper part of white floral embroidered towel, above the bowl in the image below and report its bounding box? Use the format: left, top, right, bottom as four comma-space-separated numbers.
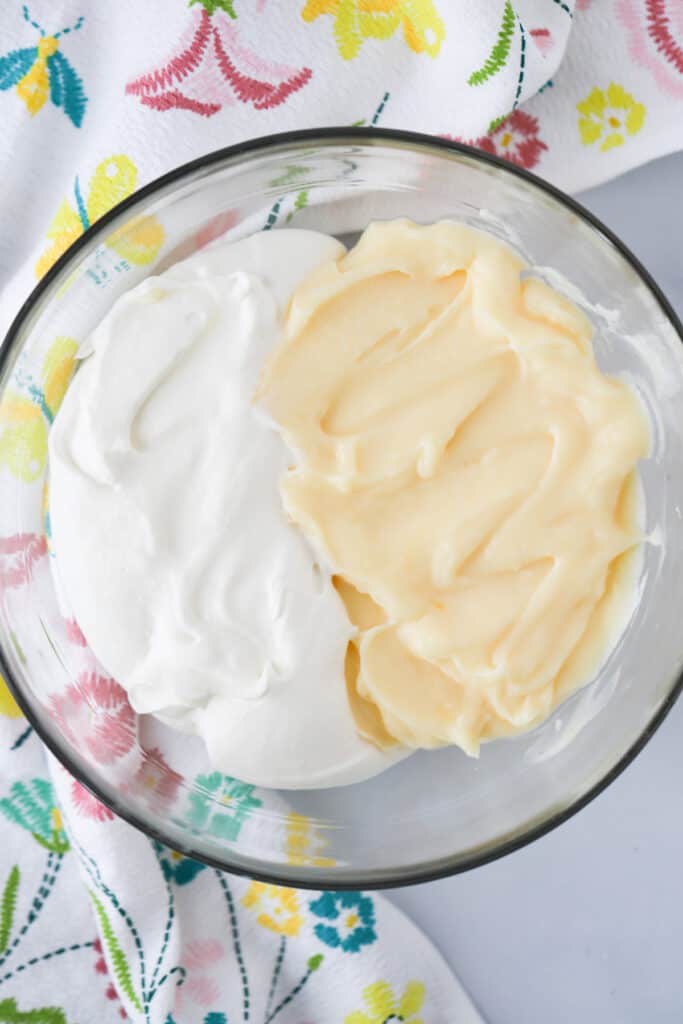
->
0, 0, 683, 330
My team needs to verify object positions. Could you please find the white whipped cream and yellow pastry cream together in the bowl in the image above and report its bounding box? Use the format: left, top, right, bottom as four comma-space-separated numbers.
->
50, 221, 649, 788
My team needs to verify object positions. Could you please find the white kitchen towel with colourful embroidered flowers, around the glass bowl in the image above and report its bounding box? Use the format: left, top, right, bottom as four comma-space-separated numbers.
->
0, 0, 683, 1024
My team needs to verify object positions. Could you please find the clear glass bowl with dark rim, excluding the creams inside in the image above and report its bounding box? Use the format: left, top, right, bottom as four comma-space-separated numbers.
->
0, 129, 683, 889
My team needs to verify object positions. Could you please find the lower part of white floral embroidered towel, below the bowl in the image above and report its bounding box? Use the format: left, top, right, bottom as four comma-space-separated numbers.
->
0, 700, 481, 1024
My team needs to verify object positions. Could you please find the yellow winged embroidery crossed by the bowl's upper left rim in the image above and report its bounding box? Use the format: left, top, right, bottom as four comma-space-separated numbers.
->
35, 154, 164, 278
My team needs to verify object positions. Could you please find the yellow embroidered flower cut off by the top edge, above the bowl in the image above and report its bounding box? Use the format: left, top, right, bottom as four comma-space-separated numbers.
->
301, 0, 445, 60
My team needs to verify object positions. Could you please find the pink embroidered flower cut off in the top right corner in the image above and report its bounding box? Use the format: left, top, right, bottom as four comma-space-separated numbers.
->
616, 0, 683, 99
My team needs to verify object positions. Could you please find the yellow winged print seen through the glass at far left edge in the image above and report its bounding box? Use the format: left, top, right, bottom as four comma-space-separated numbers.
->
0, 337, 78, 483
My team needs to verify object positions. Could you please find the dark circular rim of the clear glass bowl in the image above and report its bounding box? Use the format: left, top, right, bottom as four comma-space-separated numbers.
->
0, 127, 683, 891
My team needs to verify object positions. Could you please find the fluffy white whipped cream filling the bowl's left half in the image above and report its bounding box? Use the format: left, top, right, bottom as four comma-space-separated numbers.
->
49, 230, 400, 788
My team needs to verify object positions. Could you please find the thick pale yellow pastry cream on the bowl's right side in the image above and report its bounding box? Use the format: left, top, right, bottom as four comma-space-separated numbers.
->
257, 220, 649, 754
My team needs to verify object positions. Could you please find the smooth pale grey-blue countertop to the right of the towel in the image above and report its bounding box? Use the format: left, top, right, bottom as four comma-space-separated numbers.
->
388, 154, 683, 1024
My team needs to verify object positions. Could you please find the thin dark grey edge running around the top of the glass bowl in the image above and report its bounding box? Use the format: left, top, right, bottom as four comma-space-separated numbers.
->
0, 128, 683, 890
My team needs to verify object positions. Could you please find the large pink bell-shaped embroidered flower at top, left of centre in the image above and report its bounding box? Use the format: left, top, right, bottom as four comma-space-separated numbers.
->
126, 6, 312, 118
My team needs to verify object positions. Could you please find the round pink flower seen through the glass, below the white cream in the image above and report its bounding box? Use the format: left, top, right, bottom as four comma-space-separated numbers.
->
50, 672, 135, 765
